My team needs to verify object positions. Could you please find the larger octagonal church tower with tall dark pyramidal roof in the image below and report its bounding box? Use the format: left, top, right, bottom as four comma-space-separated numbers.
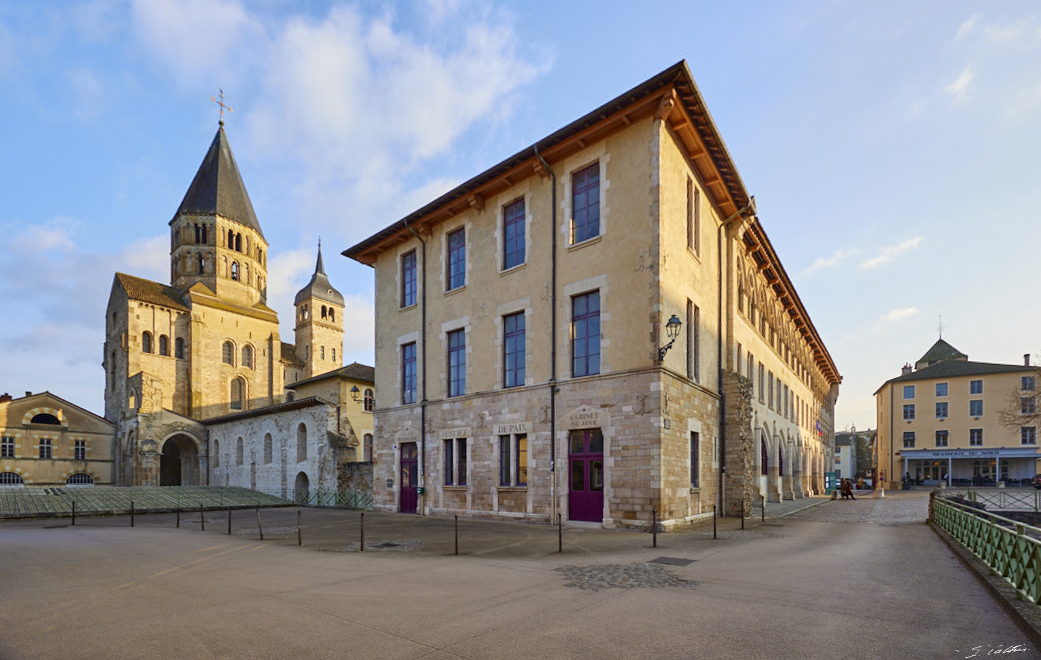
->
170, 122, 268, 307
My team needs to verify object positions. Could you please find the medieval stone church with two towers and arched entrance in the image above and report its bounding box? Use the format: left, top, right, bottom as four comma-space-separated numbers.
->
104, 122, 371, 492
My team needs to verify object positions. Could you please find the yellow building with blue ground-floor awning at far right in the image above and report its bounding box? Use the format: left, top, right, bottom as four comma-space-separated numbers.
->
874, 338, 1041, 488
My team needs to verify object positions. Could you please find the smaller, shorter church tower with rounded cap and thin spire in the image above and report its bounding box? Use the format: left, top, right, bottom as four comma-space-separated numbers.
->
295, 242, 344, 378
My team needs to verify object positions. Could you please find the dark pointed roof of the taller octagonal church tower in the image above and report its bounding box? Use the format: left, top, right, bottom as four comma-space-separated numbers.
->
171, 123, 263, 238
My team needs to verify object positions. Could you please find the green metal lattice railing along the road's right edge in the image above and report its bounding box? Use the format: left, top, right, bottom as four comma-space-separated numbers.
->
933, 498, 1041, 604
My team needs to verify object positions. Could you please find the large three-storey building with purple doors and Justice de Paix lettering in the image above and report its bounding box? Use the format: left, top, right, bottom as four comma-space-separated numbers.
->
344, 62, 840, 527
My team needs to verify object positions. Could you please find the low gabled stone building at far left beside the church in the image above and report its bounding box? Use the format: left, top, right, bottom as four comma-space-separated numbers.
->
0, 391, 112, 486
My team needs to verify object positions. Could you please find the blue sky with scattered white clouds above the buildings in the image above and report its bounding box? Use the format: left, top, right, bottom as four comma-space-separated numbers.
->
0, 0, 1041, 430
